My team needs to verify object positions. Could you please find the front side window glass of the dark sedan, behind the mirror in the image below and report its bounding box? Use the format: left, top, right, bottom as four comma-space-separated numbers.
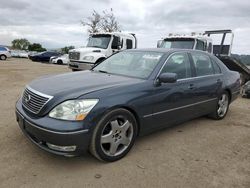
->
161, 53, 191, 79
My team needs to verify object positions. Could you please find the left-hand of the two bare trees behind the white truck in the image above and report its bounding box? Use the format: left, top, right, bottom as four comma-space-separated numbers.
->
81, 10, 101, 33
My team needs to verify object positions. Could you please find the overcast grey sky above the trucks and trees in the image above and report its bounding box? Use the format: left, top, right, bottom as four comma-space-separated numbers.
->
0, 0, 250, 54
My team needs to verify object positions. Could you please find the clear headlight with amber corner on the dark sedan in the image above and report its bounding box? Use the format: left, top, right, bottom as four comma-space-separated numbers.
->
49, 99, 99, 121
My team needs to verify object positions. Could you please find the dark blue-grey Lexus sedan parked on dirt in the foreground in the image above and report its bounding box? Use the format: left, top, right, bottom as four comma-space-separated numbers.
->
16, 49, 240, 162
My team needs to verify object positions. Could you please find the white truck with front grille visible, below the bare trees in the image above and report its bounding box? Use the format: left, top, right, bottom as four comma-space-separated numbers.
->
69, 32, 137, 71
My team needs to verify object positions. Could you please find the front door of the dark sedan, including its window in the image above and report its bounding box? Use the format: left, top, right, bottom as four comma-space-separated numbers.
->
149, 52, 196, 128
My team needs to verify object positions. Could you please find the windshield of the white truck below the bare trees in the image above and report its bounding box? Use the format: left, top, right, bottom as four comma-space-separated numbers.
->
87, 35, 111, 49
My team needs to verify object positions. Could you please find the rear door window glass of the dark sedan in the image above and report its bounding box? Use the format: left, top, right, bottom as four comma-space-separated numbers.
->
191, 53, 214, 76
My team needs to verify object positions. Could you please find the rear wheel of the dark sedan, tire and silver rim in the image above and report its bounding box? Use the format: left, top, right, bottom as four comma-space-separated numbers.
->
209, 91, 230, 120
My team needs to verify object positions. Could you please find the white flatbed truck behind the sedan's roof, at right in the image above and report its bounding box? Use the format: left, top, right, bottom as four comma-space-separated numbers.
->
157, 29, 250, 84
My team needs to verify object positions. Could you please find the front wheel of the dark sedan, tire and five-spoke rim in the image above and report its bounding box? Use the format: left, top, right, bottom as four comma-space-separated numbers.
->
90, 109, 138, 162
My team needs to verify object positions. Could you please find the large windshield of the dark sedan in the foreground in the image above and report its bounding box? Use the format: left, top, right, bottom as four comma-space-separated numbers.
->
93, 51, 163, 79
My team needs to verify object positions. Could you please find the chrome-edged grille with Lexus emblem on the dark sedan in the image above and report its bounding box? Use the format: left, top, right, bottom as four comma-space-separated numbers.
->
22, 87, 53, 114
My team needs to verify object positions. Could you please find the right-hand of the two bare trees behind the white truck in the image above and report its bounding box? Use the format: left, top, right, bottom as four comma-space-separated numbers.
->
101, 8, 121, 32
